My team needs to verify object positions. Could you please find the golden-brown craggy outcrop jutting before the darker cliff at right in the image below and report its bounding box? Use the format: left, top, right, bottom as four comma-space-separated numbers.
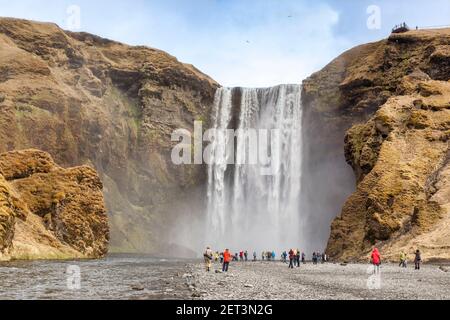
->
328, 79, 450, 259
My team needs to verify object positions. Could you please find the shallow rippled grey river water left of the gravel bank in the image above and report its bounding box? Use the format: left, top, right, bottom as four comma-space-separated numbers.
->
0, 255, 191, 300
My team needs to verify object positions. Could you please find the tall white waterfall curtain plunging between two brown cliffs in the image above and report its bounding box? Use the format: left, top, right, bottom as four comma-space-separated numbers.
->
205, 85, 305, 252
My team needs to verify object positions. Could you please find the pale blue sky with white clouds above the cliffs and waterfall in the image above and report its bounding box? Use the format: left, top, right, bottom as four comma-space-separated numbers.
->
0, 0, 450, 87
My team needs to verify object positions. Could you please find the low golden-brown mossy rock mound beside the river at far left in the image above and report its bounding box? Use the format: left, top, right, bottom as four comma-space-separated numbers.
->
0, 150, 109, 260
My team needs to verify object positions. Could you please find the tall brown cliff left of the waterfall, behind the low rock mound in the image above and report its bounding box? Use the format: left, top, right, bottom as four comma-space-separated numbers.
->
0, 18, 218, 253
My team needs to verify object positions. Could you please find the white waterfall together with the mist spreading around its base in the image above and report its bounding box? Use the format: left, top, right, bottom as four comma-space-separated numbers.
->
167, 85, 355, 258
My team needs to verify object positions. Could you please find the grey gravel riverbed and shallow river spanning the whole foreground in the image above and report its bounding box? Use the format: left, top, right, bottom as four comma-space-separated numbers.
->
0, 255, 450, 300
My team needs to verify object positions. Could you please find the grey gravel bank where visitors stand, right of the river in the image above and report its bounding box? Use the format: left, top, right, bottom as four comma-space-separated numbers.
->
182, 261, 450, 300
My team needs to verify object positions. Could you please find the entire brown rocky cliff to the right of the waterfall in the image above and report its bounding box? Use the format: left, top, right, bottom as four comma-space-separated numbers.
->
303, 29, 450, 260
